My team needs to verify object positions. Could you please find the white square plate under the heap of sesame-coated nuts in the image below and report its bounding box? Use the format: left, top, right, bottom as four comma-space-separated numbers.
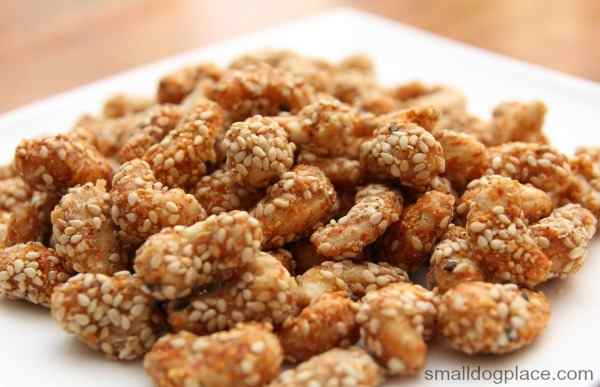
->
0, 9, 600, 387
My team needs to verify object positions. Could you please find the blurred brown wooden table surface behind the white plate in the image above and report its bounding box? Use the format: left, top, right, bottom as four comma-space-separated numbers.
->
0, 0, 600, 112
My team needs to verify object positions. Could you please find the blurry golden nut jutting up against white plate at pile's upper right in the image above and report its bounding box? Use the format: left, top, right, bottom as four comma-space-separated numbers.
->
481, 101, 548, 146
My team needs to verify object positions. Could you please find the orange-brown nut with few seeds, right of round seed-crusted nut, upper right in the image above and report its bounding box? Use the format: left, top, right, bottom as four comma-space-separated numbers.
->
436, 130, 489, 191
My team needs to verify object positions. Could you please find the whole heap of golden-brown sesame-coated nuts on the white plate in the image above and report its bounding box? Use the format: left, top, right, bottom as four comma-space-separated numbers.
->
0, 51, 600, 387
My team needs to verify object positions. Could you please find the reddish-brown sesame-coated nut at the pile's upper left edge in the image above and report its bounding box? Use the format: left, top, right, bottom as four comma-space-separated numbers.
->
15, 134, 112, 192
